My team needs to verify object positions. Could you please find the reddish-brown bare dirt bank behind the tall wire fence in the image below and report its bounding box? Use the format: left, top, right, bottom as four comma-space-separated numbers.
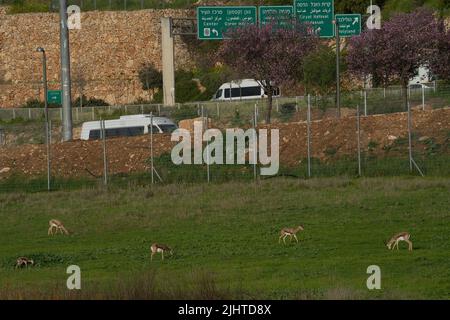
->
0, 108, 450, 179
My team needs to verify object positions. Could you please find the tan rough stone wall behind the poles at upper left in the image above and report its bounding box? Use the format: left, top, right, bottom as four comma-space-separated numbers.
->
0, 8, 191, 108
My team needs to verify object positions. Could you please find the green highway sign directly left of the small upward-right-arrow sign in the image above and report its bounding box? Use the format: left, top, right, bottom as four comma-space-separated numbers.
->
294, 0, 334, 38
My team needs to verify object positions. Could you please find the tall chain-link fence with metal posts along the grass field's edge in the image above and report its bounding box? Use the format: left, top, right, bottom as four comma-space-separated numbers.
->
0, 86, 450, 192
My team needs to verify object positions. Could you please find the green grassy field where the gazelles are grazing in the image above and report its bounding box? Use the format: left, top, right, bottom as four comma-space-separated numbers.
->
0, 178, 450, 299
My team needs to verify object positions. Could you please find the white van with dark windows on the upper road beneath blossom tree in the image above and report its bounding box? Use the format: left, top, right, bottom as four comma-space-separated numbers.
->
211, 79, 280, 101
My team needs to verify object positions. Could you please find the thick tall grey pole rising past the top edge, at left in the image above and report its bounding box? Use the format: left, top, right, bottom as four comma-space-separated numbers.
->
59, 0, 72, 141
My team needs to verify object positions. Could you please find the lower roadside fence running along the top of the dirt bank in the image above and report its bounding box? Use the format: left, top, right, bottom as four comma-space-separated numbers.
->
0, 84, 450, 124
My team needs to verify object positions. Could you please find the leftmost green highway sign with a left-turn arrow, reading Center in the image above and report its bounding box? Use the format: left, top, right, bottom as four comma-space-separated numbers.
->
197, 6, 257, 40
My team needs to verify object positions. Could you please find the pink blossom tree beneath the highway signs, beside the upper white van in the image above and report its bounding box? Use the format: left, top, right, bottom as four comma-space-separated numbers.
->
218, 21, 318, 123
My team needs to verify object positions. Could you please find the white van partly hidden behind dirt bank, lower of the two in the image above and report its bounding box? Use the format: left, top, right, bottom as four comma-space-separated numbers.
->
80, 114, 177, 140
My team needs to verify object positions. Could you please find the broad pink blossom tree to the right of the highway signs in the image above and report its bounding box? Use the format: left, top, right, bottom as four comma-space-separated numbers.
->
347, 9, 442, 109
